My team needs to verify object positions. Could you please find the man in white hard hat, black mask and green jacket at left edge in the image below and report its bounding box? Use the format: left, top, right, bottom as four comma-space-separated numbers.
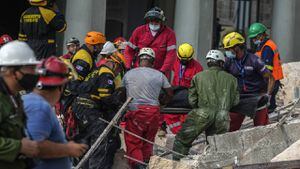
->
0, 41, 39, 169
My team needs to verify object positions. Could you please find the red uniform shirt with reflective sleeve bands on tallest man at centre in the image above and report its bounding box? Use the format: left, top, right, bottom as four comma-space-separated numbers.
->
125, 24, 176, 73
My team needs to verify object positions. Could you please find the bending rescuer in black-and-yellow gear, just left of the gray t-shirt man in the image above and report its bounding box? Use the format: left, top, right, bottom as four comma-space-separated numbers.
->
72, 52, 125, 169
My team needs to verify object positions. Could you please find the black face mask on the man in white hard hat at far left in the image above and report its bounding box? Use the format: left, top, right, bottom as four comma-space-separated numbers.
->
17, 72, 39, 91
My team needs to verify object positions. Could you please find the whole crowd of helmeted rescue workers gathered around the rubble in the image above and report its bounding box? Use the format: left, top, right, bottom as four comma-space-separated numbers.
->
0, 0, 283, 169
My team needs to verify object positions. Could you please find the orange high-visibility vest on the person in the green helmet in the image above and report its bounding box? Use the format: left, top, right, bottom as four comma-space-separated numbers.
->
255, 39, 283, 80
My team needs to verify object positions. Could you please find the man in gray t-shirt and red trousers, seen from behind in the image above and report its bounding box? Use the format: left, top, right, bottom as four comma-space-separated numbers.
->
122, 48, 173, 169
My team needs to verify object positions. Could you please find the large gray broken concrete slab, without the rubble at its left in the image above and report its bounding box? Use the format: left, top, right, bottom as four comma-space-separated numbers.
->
201, 123, 300, 167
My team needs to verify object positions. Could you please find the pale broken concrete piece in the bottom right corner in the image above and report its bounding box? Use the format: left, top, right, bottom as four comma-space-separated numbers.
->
271, 140, 300, 162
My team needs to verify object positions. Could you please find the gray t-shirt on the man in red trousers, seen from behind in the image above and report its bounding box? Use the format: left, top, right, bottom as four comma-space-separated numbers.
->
122, 67, 171, 107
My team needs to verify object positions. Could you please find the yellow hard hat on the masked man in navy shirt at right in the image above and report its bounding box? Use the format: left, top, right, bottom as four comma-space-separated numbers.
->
223, 32, 245, 49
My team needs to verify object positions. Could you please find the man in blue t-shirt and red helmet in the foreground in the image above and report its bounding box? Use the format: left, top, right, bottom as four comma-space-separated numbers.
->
22, 56, 88, 169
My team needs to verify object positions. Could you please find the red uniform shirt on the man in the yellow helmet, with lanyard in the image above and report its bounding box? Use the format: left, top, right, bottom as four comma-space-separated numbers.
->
172, 58, 203, 87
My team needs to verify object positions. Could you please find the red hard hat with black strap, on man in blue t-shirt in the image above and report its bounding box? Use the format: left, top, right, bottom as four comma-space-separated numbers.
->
37, 56, 69, 88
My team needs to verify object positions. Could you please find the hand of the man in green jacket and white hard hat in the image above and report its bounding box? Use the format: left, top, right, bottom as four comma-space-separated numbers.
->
20, 138, 39, 157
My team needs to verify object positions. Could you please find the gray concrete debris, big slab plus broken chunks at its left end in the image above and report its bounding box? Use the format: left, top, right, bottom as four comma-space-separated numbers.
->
151, 121, 300, 168
